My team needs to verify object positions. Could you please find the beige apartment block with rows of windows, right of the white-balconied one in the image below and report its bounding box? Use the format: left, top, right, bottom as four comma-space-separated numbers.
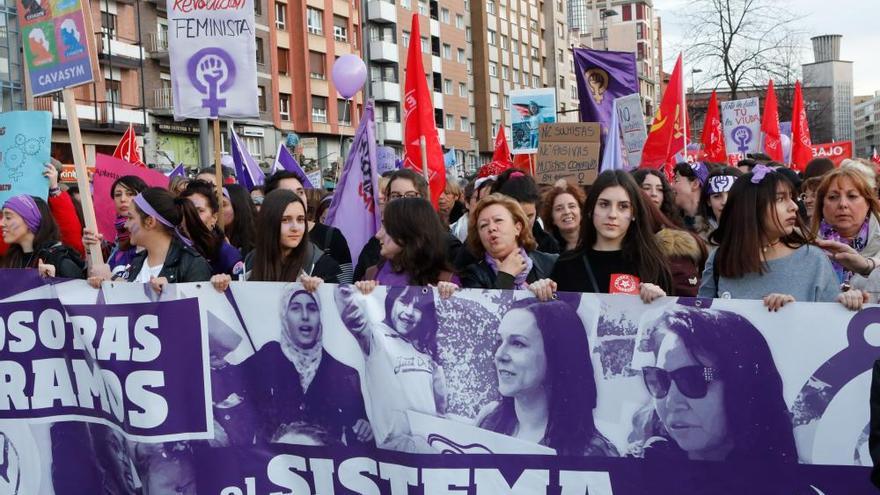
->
471, 0, 558, 160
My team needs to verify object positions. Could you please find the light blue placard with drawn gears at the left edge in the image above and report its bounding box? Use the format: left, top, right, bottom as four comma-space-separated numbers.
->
0, 112, 52, 204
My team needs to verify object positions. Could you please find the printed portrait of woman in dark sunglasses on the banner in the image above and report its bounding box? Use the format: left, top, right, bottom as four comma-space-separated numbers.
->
631, 306, 798, 463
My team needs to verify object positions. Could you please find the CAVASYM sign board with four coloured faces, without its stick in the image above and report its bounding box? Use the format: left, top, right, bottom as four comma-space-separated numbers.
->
17, 0, 94, 96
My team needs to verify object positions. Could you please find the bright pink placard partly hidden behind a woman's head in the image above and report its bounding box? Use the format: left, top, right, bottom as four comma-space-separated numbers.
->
93, 153, 168, 240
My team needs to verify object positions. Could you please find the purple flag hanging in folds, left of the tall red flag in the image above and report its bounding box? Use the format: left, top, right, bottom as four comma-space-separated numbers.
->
326, 101, 381, 260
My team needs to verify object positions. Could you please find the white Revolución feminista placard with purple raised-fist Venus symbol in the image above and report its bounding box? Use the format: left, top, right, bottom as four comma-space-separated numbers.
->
167, 0, 260, 120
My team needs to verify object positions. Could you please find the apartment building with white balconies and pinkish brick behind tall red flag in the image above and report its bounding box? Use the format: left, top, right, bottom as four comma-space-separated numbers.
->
364, 0, 478, 173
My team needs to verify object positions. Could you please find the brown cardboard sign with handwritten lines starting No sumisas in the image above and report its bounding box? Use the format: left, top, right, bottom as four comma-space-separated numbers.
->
535, 122, 602, 186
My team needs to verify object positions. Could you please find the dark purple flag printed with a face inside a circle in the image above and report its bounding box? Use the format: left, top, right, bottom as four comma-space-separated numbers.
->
574, 48, 639, 136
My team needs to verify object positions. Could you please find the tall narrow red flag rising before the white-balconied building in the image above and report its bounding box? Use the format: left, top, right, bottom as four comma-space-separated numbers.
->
403, 14, 446, 206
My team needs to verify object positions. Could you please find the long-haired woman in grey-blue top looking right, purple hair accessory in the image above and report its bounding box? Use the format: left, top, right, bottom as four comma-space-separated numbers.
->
699, 165, 863, 311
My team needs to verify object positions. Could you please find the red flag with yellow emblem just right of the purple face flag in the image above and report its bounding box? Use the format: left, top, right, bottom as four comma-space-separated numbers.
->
641, 55, 687, 168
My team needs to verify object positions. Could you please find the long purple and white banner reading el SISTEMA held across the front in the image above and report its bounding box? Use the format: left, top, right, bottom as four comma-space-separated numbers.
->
0, 272, 880, 495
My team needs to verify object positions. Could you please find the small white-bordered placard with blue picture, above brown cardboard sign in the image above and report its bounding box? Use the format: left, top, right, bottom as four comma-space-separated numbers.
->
509, 88, 556, 155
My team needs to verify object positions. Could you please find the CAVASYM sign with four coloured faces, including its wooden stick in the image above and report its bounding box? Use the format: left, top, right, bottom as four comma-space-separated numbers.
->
18, 0, 103, 265
